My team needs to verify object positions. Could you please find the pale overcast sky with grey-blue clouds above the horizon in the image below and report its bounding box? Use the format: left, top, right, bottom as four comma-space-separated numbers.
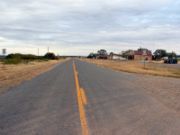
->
0, 0, 180, 55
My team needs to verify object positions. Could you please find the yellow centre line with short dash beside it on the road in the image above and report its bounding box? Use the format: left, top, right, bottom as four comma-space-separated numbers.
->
73, 61, 89, 135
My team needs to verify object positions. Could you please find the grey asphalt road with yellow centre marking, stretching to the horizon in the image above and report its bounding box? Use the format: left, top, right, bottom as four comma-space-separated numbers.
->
0, 60, 180, 135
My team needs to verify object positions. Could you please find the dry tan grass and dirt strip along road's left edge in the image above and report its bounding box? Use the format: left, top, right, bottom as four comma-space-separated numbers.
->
0, 60, 64, 94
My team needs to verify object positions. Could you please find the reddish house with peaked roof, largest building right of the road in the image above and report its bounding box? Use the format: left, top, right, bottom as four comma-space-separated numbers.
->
134, 48, 152, 60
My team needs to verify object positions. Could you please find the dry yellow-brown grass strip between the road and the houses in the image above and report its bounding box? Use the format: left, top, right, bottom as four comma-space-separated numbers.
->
82, 59, 180, 78
